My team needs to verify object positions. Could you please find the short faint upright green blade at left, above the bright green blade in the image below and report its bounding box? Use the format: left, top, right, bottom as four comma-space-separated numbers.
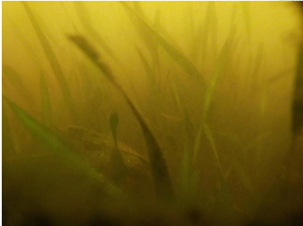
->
40, 71, 53, 127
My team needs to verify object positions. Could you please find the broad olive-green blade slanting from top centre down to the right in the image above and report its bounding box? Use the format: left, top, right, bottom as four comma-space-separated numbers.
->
121, 2, 205, 85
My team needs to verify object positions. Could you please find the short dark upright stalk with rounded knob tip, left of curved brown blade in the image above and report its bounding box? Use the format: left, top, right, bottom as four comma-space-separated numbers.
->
109, 112, 126, 185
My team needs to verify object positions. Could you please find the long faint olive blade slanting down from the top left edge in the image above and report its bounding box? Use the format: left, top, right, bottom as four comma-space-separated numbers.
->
22, 2, 78, 122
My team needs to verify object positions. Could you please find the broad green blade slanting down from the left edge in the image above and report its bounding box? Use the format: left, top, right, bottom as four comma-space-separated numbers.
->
3, 96, 120, 195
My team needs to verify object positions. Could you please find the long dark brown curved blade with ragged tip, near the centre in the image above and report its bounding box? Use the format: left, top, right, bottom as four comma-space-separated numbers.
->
69, 35, 173, 198
